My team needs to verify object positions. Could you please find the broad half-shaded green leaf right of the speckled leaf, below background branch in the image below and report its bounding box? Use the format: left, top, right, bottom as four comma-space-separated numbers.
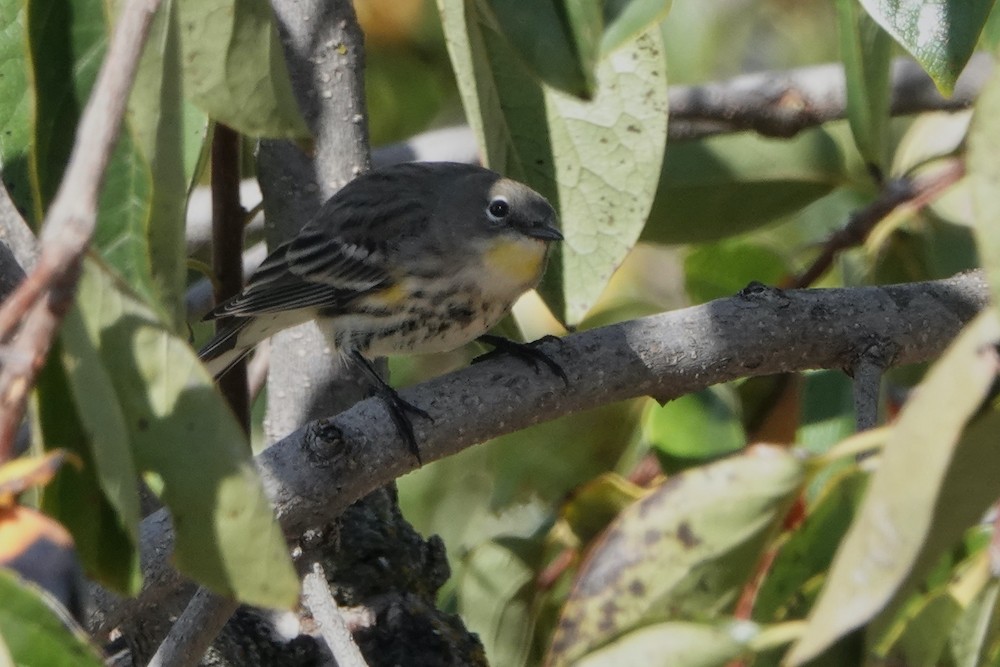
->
642, 123, 853, 244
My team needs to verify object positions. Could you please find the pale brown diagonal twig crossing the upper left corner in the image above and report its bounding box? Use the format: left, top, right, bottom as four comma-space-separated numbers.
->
0, 0, 159, 461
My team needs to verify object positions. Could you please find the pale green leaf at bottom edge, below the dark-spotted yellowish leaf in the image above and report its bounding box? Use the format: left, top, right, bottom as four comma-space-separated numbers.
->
573, 622, 756, 667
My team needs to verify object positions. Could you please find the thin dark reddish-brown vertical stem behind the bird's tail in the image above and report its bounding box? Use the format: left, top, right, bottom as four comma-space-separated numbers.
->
212, 123, 250, 432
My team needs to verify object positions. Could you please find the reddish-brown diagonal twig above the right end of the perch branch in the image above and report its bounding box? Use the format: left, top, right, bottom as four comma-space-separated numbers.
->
783, 158, 965, 288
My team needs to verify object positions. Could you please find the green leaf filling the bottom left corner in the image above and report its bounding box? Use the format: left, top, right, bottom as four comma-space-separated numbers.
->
0, 569, 104, 667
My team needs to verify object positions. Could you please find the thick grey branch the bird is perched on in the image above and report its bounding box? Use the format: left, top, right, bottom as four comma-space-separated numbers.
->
91, 272, 989, 633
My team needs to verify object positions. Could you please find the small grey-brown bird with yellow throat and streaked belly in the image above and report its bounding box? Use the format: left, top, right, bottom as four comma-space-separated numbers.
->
199, 162, 565, 458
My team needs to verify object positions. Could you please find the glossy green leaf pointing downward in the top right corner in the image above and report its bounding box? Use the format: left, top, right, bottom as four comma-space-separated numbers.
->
861, 0, 993, 95
